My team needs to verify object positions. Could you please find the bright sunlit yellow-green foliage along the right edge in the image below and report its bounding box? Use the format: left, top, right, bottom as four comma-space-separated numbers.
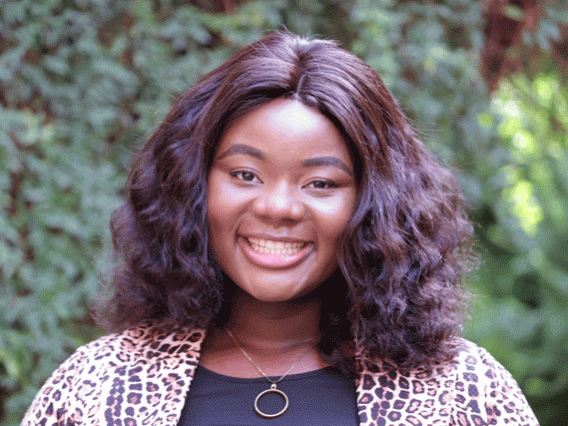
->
469, 72, 568, 424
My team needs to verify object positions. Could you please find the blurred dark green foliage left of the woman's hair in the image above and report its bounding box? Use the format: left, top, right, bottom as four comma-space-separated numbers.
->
0, 0, 274, 424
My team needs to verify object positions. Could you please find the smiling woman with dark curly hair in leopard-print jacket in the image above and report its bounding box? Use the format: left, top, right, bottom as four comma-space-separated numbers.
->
23, 32, 538, 425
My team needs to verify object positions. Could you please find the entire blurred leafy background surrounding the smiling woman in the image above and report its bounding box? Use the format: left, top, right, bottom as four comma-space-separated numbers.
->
0, 0, 568, 426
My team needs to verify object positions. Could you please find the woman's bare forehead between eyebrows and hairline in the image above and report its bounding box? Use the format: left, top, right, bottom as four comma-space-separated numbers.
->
216, 98, 351, 159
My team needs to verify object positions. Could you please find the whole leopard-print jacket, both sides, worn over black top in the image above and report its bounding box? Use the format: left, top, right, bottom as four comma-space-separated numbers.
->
22, 323, 538, 426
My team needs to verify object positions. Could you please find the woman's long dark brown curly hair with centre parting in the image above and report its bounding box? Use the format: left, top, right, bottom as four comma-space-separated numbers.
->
98, 32, 473, 369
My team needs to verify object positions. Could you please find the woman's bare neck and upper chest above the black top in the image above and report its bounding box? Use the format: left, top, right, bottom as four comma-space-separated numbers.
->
200, 289, 328, 378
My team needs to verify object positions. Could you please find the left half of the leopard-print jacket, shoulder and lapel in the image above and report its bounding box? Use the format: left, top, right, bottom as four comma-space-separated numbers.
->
21, 323, 205, 426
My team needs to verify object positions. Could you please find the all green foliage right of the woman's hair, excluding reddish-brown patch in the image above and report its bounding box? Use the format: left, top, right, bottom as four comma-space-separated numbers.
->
346, 1, 568, 424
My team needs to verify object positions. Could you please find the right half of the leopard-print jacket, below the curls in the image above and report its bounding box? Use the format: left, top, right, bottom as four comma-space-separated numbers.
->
358, 339, 538, 426
